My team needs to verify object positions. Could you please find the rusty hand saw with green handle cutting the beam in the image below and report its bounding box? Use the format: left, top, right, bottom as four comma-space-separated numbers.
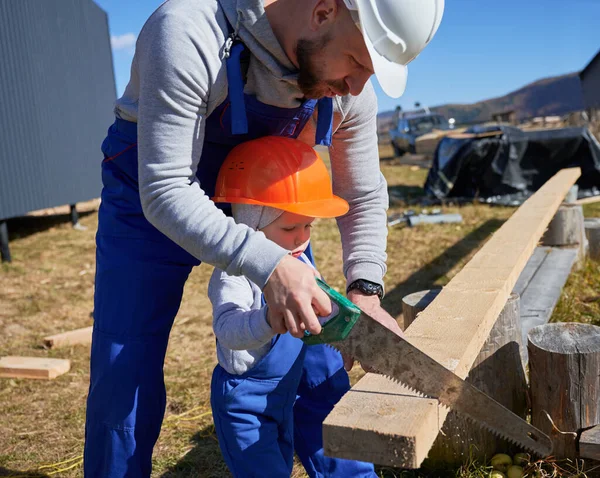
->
303, 279, 552, 457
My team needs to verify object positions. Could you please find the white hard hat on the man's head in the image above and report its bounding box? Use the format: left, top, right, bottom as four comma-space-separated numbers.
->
344, 0, 444, 98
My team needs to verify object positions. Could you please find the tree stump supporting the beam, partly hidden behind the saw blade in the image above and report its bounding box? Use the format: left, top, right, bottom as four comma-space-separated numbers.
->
410, 290, 527, 465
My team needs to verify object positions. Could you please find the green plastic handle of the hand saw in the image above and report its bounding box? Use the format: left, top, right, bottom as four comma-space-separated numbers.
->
302, 278, 361, 345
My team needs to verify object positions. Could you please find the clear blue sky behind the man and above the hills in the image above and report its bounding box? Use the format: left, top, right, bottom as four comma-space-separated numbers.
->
95, 0, 600, 111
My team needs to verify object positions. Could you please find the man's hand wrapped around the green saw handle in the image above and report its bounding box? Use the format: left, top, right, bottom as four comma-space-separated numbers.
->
263, 256, 331, 338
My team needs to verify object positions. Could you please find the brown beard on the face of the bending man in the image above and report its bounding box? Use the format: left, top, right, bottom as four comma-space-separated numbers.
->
296, 34, 349, 99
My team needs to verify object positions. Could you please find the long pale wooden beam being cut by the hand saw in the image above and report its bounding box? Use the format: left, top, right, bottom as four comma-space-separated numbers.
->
323, 168, 581, 468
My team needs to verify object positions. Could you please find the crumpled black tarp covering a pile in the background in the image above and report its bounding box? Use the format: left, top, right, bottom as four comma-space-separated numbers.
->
425, 126, 600, 205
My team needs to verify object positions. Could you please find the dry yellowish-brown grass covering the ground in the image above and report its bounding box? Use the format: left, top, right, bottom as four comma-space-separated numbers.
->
0, 161, 600, 478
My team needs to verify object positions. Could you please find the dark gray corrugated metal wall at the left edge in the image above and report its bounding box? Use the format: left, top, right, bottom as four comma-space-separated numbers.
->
0, 0, 116, 219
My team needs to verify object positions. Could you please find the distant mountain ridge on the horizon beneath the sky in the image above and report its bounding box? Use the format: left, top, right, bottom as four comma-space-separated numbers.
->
378, 72, 583, 131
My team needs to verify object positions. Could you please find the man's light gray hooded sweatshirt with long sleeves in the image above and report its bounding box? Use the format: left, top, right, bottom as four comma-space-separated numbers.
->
115, 0, 388, 289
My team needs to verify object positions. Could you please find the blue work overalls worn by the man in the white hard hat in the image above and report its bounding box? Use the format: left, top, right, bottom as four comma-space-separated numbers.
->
84, 36, 374, 478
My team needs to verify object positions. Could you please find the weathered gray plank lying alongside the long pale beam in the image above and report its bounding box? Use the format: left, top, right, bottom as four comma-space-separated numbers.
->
521, 248, 578, 354
